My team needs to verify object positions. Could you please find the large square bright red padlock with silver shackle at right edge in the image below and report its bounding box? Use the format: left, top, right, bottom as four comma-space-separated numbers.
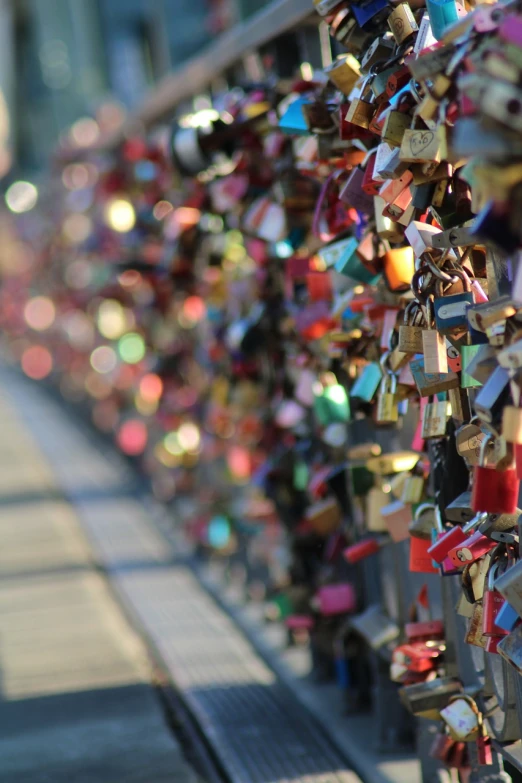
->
471, 435, 520, 514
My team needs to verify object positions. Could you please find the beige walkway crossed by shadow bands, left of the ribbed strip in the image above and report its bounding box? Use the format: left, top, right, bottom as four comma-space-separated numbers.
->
0, 394, 198, 783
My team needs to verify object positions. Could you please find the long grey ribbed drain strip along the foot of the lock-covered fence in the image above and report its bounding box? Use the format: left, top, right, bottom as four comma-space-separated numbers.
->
7, 373, 359, 783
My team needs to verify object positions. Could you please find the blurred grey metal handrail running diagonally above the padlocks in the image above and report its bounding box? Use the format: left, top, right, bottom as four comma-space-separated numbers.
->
99, 0, 312, 149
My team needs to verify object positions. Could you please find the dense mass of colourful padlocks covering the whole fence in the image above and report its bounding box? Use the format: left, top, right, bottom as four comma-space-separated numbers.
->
5, 0, 522, 770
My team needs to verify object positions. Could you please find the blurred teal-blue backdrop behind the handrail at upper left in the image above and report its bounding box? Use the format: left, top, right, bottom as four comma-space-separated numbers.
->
0, 0, 276, 176
